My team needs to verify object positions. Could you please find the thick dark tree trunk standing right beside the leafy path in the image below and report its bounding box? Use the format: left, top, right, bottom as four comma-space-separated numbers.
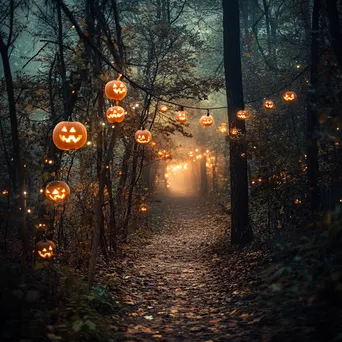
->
222, 0, 253, 245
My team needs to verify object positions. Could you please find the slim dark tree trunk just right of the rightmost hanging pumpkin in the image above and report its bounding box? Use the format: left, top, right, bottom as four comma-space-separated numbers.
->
307, 0, 321, 212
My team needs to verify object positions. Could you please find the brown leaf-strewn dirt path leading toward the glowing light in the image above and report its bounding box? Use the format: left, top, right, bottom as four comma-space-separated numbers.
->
113, 197, 264, 341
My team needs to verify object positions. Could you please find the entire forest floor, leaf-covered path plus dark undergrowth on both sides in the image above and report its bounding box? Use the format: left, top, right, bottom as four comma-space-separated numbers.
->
0, 195, 342, 342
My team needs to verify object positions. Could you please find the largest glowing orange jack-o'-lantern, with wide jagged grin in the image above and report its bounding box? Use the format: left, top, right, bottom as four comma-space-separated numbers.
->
52, 121, 87, 151
